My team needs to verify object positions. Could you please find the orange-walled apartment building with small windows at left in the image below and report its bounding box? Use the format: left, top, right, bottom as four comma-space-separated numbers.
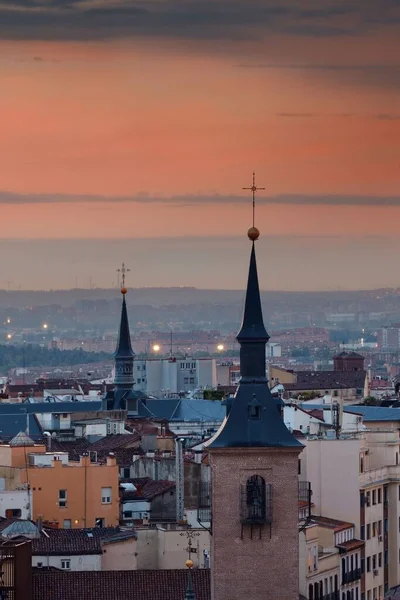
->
0, 432, 119, 529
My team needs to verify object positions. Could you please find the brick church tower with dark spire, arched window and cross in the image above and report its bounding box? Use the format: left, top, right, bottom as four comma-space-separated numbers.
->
208, 180, 302, 600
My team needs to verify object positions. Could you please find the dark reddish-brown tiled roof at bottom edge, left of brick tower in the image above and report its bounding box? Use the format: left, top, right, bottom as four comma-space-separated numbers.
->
33, 569, 211, 600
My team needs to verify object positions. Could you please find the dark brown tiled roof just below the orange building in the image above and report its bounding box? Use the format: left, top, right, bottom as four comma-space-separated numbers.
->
32, 527, 121, 556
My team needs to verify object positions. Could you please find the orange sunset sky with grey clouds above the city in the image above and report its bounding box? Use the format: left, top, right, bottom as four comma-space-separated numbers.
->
0, 0, 400, 290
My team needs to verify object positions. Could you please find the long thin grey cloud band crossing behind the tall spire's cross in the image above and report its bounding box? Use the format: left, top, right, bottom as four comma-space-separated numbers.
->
0, 190, 400, 206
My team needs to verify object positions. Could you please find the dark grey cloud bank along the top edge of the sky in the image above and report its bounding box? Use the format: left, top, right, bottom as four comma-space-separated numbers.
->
0, 0, 400, 40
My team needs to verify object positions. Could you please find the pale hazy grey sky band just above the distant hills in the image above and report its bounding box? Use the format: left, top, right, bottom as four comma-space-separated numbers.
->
0, 235, 400, 291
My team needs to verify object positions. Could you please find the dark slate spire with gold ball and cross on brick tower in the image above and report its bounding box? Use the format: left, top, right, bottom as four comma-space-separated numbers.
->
208, 178, 301, 448
